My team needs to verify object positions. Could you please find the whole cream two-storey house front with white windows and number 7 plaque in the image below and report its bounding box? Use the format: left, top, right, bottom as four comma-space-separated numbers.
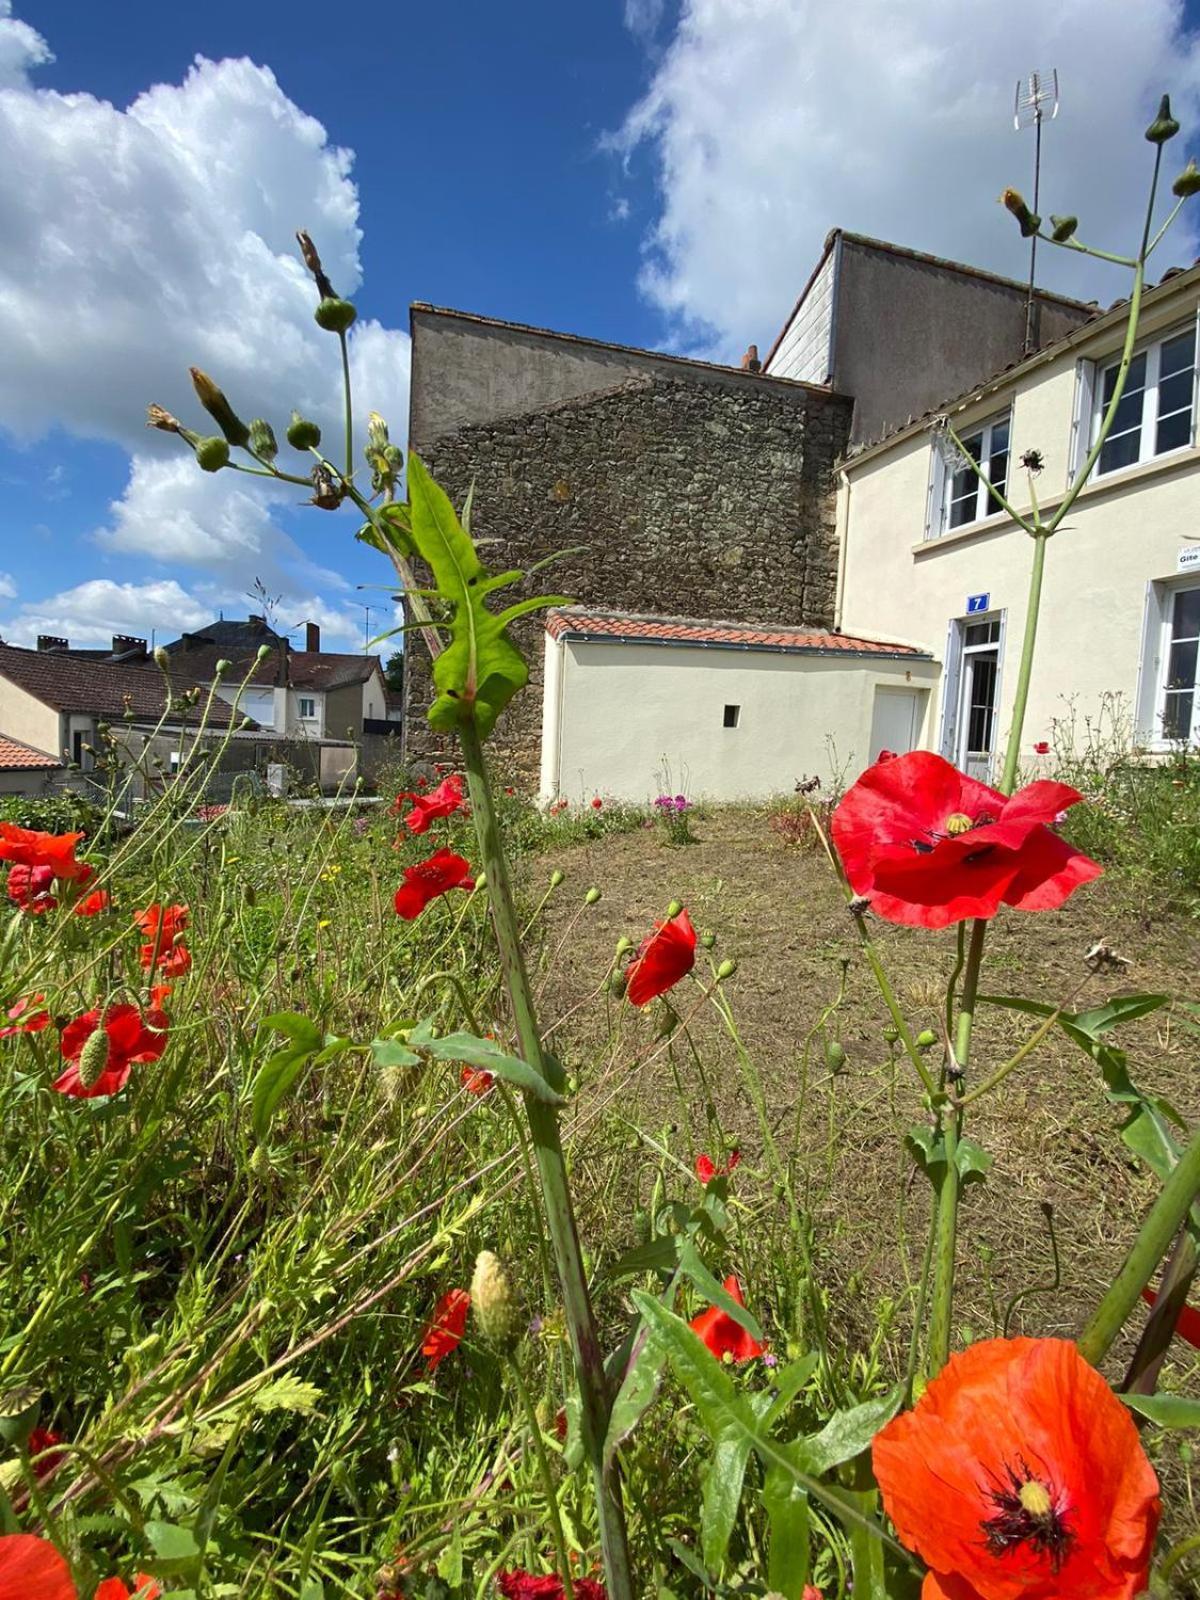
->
837, 267, 1200, 774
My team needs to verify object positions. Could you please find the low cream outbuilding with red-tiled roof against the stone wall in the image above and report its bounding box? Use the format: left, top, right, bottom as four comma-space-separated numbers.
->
541, 606, 939, 803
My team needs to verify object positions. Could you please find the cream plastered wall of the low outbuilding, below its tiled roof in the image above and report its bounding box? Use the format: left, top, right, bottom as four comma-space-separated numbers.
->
542, 637, 938, 802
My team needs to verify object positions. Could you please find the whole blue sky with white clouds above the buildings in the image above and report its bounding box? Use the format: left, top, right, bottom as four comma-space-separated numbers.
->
0, 0, 1200, 648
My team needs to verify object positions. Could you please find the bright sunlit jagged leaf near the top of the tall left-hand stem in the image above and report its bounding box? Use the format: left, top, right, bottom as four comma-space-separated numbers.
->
408, 454, 565, 738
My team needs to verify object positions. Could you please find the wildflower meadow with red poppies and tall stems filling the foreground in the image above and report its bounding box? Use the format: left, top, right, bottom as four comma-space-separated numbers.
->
0, 101, 1200, 1600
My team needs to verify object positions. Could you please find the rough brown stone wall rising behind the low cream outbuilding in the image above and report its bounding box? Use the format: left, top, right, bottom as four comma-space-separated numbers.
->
405, 364, 850, 787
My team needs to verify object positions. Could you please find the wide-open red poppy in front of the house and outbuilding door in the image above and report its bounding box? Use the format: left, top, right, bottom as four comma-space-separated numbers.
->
832, 750, 1101, 928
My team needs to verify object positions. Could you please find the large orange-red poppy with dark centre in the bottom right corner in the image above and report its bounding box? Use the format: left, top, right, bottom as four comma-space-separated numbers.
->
872, 1339, 1162, 1600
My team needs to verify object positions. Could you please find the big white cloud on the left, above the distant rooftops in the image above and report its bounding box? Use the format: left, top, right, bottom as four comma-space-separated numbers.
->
0, 18, 408, 626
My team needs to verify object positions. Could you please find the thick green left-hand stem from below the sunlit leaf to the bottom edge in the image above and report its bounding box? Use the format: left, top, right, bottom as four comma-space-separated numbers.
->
459, 718, 634, 1600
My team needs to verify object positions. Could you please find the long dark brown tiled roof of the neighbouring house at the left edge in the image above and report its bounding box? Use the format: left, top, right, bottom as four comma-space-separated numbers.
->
0, 645, 249, 726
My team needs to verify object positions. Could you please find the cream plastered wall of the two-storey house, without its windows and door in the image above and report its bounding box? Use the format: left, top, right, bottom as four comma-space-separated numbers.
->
838, 274, 1200, 749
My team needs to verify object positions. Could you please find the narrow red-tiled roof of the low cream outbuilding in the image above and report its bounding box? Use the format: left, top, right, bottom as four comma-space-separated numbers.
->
546, 606, 933, 661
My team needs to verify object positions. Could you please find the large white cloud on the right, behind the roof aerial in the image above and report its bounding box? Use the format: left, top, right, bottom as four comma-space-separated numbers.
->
611, 0, 1200, 358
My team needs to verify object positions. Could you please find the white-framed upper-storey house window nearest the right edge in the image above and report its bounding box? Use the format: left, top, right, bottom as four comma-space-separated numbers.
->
1091, 326, 1195, 477
